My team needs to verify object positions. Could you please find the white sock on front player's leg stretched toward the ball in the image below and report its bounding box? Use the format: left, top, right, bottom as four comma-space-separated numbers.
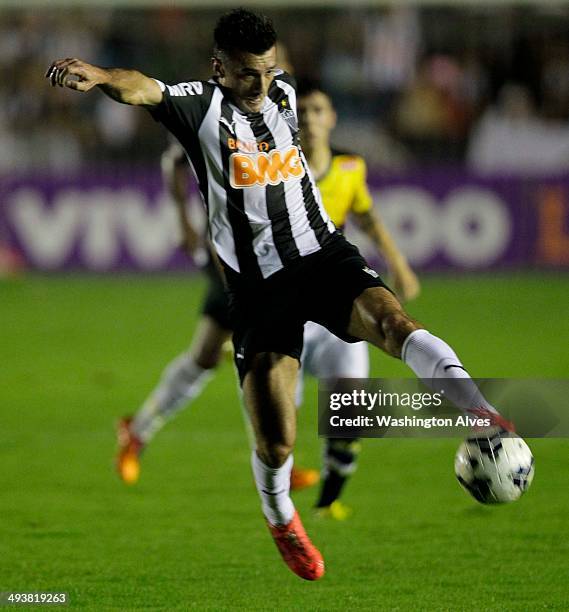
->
401, 329, 497, 412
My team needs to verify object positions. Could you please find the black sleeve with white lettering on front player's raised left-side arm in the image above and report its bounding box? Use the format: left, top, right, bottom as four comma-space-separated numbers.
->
148, 79, 215, 140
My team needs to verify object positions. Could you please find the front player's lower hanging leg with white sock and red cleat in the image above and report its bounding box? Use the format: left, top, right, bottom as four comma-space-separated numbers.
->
243, 352, 324, 580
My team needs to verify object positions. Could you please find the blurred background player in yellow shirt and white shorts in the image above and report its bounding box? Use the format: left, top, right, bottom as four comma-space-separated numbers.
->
297, 82, 419, 520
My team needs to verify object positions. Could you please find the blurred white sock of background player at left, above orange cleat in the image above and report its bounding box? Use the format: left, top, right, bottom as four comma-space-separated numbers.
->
131, 353, 211, 443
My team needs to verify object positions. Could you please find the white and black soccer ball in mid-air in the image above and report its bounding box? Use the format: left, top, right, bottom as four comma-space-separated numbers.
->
454, 431, 534, 504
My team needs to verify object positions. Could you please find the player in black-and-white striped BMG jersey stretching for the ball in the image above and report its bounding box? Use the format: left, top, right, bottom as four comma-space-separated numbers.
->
46, 9, 510, 580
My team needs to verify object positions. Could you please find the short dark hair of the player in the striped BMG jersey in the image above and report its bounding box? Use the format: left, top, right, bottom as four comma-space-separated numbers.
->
213, 8, 277, 56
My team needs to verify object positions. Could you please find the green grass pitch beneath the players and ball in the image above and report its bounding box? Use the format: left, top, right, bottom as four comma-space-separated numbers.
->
0, 275, 569, 612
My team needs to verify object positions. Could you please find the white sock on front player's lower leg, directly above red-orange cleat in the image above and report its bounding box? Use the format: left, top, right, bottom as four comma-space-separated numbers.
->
251, 451, 294, 525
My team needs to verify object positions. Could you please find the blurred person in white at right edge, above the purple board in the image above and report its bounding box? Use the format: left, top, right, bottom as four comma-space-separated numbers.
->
468, 83, 569, 174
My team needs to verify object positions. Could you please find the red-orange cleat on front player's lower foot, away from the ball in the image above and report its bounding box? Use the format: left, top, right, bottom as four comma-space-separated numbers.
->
267, 511, 324, 580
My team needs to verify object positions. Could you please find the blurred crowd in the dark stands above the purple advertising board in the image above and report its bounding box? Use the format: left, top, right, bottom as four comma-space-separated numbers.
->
0, 5, 569, 172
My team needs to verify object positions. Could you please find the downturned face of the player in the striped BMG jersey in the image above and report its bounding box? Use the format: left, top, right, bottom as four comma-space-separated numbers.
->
213, 47, 277, 113
